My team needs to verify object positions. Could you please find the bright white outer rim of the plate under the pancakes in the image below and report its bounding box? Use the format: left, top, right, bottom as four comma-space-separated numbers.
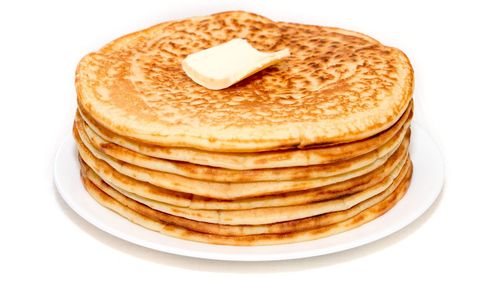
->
53, 122, 445, 261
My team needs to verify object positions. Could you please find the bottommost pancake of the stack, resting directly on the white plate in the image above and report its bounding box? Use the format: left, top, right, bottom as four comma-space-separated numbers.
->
83, 161, 411, 246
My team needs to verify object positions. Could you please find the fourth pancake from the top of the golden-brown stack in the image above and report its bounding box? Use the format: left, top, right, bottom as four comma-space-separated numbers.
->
74, 123, 405, 200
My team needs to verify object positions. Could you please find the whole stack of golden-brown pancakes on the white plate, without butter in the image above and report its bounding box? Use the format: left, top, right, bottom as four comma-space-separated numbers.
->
73, 11, 413, 245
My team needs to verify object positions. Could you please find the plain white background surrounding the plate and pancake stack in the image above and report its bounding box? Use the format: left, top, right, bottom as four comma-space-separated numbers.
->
0, 0, 500, 280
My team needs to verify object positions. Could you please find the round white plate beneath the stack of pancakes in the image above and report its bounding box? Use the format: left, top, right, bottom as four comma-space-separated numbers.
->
54, 124, 444, 261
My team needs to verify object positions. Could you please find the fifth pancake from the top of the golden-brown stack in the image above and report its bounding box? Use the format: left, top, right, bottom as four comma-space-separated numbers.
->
77, 133, 408, 210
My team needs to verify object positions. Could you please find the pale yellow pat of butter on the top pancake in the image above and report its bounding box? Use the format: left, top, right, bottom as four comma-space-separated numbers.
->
182, 39, 290, 90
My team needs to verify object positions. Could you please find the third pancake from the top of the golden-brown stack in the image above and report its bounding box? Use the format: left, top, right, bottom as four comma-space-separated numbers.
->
75, 111, 409, 182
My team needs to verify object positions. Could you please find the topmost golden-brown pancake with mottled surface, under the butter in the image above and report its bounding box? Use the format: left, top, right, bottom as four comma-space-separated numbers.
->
76, 12, 413, 152
